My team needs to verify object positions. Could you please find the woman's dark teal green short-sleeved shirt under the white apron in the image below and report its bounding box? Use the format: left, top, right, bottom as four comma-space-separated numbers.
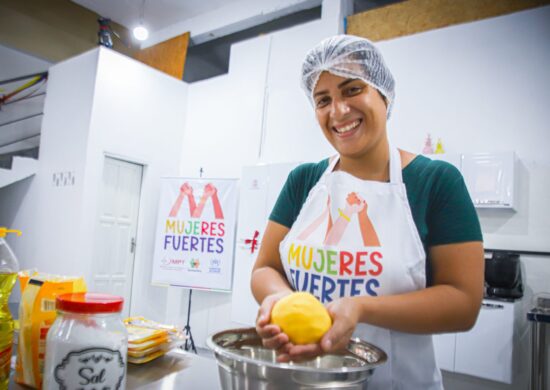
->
269, 156, 483, 285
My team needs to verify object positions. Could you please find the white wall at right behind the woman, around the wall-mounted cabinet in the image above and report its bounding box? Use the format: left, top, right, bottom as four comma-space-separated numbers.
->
380, 7, 550, 252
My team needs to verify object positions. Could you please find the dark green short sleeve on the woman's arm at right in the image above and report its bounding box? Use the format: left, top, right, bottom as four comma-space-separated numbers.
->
427, 163, 483, 246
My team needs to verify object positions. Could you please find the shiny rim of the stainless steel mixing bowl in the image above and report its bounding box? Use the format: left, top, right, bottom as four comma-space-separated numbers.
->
206, 332, 387, 374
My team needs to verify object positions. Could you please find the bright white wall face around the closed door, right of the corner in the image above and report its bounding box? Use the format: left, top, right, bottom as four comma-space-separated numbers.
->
80, 48, 187, 319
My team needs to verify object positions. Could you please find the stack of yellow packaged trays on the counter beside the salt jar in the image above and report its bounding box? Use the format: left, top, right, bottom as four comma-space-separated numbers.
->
124, 317, 185, 364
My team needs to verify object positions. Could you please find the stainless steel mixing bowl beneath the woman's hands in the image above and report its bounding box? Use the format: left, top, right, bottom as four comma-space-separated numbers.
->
206, 328, 387, 390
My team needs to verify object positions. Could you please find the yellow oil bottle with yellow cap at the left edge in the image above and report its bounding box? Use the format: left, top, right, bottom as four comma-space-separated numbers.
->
0, 227, 21, 389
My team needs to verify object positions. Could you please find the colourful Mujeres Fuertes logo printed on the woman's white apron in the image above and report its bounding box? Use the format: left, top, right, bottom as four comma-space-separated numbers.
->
287, 192, 384, 303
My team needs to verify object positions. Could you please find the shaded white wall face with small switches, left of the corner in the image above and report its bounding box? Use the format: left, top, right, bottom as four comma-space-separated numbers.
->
1, 48, 97, 274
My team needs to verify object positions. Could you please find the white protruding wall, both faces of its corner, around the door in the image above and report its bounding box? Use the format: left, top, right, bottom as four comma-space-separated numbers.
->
0, 47, 187, 319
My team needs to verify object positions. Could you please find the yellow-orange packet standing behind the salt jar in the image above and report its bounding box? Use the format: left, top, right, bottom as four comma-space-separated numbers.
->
15, 272, 86, 389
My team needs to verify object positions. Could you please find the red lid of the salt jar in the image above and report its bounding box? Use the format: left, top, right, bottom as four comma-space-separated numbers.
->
56, 293, 124, 313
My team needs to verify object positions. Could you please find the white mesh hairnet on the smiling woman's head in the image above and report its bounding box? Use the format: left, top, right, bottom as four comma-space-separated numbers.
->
302, 35, 395, 118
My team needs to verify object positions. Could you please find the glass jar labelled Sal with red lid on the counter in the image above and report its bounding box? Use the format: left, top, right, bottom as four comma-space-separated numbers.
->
43, 293, 128, 390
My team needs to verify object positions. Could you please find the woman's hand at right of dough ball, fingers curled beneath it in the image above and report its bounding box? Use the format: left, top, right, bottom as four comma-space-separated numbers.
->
277, 298, 359, 362
